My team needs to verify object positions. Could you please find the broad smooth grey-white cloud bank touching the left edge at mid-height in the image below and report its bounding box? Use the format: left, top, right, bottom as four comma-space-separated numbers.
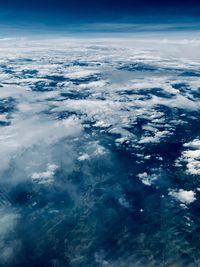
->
0, 117, 82, 176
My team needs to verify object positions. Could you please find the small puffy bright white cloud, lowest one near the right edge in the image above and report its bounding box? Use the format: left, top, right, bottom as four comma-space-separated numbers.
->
169, 189, 196, 204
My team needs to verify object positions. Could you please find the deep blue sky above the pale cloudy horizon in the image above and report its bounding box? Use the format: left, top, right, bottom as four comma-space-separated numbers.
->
0, 0, 200, 35
